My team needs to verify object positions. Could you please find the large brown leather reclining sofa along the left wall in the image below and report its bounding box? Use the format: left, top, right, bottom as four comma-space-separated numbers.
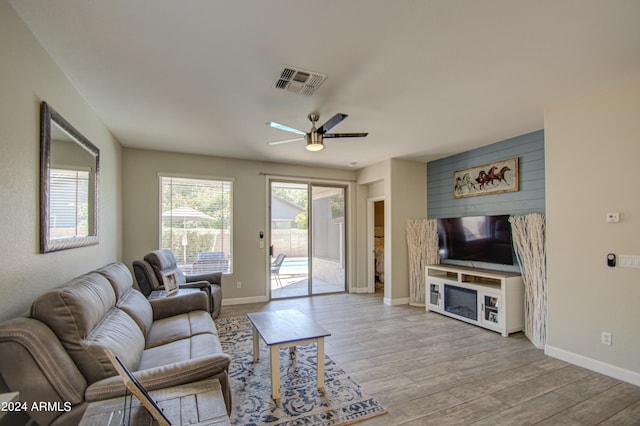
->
0, 263, 231, 426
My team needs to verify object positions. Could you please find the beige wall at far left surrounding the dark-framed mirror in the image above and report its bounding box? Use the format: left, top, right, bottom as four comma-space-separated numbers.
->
0, 1, 122, 321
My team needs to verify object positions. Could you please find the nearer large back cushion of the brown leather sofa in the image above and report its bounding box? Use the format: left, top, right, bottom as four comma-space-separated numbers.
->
31, 272, 144, 383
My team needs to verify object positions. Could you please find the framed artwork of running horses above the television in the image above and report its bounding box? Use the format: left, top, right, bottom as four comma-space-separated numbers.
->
453, 157, 519, 198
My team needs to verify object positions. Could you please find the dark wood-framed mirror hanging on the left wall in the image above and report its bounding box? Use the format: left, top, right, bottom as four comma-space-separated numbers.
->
40, 102, 100, 253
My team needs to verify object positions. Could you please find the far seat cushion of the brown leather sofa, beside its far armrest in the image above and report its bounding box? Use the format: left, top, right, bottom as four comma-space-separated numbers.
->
145, 311, 218, 349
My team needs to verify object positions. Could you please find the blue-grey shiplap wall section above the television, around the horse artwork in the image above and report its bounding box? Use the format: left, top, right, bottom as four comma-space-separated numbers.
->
427, 130, 545, 219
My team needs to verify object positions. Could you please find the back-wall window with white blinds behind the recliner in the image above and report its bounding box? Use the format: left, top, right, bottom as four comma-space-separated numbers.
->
160, 176, 233, 274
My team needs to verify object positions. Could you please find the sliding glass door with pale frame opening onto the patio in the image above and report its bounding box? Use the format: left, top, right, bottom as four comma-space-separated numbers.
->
270, 181, 346, 299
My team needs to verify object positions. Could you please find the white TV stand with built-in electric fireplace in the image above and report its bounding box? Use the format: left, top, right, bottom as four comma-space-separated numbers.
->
425, 265, 524, 337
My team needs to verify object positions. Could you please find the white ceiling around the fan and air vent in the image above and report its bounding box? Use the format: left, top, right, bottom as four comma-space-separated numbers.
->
10, 0, 640, 168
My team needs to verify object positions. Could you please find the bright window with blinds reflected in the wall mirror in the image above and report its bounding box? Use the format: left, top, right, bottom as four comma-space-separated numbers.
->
49, 169, 90, 239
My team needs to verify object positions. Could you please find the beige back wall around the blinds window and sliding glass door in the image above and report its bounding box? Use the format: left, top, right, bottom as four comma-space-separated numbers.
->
123, 149, 357, 304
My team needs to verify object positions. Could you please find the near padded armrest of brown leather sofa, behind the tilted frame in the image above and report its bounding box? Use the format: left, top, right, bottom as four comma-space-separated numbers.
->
84, 353, 231, 402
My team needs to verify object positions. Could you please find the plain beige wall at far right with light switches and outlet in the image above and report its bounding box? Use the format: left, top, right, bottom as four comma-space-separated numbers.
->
545, 80, 640, 385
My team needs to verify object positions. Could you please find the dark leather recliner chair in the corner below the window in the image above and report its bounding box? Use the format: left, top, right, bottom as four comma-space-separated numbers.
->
133, 249, 222, 318
